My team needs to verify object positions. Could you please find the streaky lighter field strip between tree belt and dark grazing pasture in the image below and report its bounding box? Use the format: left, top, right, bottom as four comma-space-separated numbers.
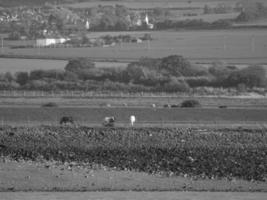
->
0, 95, 267, 109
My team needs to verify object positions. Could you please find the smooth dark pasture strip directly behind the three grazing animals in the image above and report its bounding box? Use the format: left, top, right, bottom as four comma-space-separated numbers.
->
0, 106, 267, 127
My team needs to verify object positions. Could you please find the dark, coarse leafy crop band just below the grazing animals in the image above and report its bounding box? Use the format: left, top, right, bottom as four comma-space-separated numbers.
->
0, 126, 267, 181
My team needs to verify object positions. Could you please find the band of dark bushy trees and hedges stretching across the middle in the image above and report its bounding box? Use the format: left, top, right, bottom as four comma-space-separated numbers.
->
0, 55, 267, 93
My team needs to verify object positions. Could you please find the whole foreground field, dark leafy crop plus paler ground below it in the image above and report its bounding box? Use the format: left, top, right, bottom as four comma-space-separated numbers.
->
0, 126, 267, 192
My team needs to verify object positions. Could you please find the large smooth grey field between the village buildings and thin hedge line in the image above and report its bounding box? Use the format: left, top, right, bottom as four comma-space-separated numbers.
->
4, 29, 267, 63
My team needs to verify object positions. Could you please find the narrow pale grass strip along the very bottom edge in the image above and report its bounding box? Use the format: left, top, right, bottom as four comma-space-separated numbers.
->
2, 192, 266, 200
